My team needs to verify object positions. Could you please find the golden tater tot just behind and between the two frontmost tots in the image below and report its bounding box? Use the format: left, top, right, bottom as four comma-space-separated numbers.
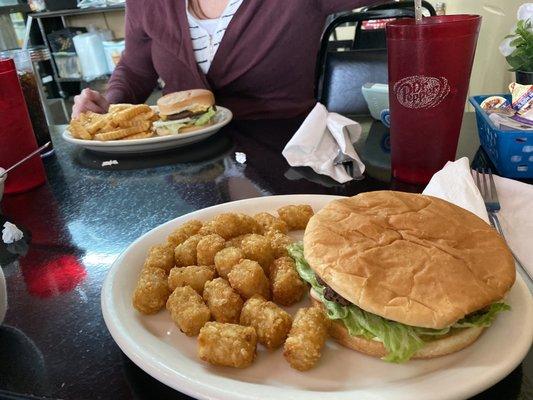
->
240, 295, 292, 350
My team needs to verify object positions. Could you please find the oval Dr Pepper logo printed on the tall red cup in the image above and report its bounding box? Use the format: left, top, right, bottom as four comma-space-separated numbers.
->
393, 75, 450, 108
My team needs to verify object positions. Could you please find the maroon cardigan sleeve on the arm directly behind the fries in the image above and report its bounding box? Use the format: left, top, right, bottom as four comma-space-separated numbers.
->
106, 0, 158, 104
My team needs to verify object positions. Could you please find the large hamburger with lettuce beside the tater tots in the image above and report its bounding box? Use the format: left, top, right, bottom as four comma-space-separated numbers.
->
289, 191, 515, 363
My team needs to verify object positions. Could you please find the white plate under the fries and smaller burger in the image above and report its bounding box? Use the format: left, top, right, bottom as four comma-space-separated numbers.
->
63, 106, 233, 154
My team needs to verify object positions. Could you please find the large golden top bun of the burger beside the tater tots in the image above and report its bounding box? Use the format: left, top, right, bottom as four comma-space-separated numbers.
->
304, 191, 515, 329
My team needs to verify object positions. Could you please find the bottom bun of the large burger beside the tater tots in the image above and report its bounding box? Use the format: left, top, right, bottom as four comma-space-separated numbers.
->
311, 297, 485, 359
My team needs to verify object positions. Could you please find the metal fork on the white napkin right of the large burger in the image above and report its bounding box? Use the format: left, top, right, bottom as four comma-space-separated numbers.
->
472, 168, 533, 281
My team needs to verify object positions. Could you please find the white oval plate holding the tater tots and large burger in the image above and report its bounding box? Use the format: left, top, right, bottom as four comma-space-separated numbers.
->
102, 195, 533, 400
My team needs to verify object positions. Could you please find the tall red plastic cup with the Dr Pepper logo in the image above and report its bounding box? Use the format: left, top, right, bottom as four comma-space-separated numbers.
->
387, 15, 481, 184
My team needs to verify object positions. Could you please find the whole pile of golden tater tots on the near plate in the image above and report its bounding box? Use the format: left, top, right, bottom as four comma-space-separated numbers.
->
133, 205, 327, 371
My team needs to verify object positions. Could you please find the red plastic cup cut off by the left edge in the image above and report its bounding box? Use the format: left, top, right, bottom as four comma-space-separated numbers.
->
0, 59, 46, 193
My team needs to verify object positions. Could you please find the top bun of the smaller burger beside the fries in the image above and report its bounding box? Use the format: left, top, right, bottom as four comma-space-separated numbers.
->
157, 89, 215, 115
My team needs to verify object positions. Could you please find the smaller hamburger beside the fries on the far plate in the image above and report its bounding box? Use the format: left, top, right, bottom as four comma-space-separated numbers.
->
154, 89, 216, 136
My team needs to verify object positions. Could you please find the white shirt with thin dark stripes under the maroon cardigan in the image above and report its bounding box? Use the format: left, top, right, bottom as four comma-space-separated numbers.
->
187, 0, 243, 74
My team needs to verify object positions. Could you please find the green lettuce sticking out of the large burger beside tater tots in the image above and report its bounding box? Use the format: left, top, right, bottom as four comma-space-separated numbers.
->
288, 243, 510, 363
